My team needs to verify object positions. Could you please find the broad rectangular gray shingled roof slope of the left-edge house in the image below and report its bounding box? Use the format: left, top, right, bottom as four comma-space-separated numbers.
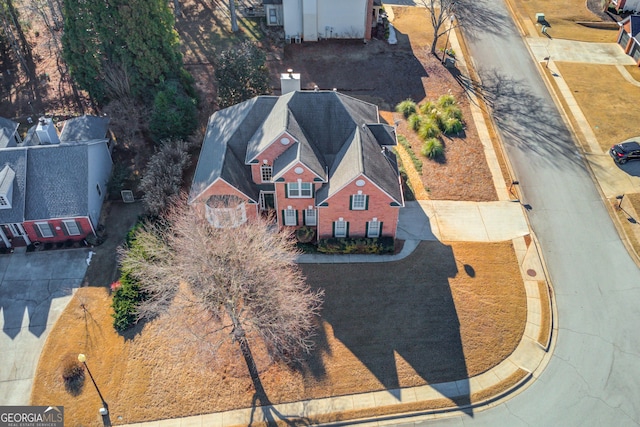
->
25, 145, 89, 220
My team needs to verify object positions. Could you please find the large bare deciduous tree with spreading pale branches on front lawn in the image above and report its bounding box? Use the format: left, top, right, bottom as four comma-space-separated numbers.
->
120, 198, 323, 403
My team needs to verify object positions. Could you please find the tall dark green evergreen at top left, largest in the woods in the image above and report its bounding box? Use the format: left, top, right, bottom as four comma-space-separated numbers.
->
62, 0, 182, 102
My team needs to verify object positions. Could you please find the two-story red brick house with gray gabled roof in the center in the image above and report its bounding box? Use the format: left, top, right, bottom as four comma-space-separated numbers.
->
189, 91, 404, 242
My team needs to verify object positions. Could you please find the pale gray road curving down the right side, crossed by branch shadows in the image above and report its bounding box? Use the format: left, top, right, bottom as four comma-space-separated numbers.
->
390, 0, 640, 427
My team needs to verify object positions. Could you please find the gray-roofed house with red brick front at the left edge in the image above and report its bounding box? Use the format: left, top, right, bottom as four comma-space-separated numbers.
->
0, 116, 112, 248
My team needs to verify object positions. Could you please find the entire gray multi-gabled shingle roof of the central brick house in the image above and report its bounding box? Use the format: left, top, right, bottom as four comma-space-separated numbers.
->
191, 91, 402, 204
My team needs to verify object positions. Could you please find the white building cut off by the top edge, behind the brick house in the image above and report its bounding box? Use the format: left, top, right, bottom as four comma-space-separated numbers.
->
263, 0, 382, 41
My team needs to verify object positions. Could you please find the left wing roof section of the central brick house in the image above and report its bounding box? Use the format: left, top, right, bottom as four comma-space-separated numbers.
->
189, 96, 278, 201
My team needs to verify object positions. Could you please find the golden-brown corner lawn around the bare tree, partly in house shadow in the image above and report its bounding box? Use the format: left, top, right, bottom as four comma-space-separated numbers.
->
31, 242, 526, 426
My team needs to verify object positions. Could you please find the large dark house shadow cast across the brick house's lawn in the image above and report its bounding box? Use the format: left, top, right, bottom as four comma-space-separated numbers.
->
301, 241, 473, 416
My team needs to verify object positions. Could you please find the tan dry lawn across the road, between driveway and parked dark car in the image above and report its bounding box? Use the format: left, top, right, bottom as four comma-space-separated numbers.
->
556, 62, 640, 151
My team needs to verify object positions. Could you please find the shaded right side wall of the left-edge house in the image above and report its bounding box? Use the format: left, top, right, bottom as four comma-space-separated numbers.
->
87, 141, 112, 229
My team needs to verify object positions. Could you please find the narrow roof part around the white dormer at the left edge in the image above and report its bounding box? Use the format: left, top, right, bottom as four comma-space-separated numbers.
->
0, 148, 27, 224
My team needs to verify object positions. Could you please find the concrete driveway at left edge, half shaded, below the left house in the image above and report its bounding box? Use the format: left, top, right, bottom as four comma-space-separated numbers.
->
0, 249, 89, 405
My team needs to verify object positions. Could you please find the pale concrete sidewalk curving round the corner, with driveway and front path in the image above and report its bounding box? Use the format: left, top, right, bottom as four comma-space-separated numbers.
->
126, 20, 551, 427
